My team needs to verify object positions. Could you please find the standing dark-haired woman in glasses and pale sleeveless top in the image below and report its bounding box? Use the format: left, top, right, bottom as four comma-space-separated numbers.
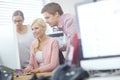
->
12, 10, 34, 68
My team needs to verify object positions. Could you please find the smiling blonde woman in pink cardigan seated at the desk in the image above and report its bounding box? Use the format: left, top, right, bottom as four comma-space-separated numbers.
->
24, 18, 59, 73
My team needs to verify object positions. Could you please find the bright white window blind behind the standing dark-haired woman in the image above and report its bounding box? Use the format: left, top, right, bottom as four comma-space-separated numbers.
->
0, 0, 50, 26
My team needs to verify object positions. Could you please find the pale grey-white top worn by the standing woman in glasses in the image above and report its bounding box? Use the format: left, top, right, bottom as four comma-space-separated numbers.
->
17, 26, 34, 68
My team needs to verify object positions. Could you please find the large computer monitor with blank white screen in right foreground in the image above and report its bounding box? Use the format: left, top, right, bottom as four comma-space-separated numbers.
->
75, 0, 120, 70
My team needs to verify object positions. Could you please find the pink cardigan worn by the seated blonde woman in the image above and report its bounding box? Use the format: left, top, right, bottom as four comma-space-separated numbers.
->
27, 38, 59, 72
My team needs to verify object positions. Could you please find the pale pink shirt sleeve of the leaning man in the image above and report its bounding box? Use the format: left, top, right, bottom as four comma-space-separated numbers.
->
64, 15, 77, 50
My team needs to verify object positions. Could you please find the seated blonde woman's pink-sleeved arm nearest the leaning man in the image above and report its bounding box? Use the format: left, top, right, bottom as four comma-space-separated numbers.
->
39, 39, 59, 72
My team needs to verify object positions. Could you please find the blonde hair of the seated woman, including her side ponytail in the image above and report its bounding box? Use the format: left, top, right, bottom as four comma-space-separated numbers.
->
31, 18, 46, 52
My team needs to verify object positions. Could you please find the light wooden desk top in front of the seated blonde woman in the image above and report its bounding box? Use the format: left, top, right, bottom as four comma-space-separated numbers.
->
13, 72, 52, 80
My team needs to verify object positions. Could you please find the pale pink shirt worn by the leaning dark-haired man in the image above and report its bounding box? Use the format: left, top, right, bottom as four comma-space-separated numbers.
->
58, 13, 77, 51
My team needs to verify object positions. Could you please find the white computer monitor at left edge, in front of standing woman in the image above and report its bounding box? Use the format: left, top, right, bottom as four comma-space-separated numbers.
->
0, 25, 20, 69
